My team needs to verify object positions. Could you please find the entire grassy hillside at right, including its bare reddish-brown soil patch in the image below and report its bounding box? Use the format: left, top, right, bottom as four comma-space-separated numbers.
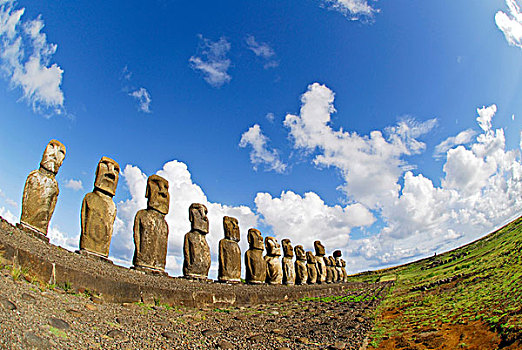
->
351, 217, 522, 349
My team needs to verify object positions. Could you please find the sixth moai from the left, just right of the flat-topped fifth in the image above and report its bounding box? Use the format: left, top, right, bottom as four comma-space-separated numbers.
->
245, 228, 266, 284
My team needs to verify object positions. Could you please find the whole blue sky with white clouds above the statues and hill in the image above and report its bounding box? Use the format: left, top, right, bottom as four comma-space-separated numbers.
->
0, 0, 522, 275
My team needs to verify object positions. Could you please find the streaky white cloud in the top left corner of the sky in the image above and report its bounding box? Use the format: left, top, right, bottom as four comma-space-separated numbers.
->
0, 1, 64, 115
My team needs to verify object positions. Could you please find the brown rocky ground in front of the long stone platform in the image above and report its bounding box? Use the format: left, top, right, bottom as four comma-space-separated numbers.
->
0, 266, 387, 349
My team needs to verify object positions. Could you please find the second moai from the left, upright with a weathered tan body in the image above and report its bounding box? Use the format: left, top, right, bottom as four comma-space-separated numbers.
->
80, 157, 120, 259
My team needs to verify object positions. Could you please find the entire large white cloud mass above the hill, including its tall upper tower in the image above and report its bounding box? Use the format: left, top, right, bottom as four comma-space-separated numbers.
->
255, 83, 522, 271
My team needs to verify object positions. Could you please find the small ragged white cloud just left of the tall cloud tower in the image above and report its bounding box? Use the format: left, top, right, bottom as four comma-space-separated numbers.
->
239, 124, 286, 173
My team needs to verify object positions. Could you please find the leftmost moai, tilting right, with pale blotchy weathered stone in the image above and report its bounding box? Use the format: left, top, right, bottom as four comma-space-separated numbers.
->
20, 140, 65, 241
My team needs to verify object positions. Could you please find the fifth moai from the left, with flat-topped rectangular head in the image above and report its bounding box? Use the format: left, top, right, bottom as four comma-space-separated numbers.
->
218, 216, 241, 283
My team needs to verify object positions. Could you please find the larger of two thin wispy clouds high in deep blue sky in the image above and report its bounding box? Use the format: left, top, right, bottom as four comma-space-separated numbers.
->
189, 35, 231, 87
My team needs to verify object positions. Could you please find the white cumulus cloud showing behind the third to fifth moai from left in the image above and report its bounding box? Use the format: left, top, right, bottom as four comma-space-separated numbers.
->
111, 160, 258, 277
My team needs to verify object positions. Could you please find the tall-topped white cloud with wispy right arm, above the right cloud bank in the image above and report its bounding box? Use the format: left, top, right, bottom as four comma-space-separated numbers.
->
284, 83, 436, 209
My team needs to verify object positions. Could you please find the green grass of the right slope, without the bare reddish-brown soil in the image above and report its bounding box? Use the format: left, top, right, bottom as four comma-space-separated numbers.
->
350, 217, 522, 348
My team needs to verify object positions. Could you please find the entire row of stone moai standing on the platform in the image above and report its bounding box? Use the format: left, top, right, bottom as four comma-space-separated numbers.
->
20, 140, 347, 285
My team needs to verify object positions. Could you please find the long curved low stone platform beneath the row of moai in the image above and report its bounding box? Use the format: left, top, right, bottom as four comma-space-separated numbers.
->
0, 217, 353, 307
